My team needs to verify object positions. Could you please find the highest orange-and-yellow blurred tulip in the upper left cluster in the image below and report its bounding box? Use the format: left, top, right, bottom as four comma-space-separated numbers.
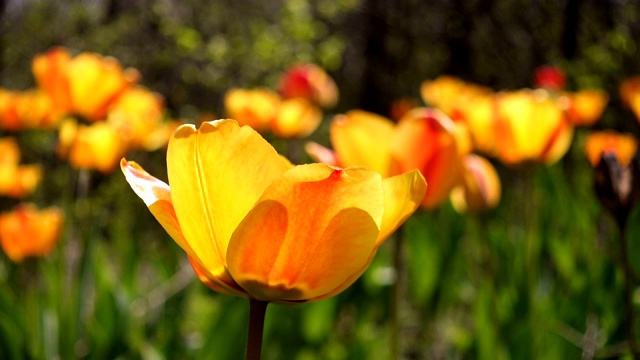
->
32, 48, 140, 121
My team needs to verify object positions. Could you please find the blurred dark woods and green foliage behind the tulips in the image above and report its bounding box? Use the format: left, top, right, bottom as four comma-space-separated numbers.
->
0, 0, 640, 360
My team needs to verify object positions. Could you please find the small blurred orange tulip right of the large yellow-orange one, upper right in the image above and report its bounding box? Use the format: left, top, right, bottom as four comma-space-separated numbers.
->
564, 89, 609, 126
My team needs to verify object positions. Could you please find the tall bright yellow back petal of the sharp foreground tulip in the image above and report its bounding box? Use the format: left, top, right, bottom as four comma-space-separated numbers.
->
167, 120, 289, 284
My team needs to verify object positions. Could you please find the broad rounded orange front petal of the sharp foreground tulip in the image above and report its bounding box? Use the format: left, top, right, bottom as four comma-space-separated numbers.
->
227, 164, 384, 301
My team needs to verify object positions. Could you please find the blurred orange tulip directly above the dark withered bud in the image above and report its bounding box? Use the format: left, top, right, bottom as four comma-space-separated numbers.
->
585, 131, 638, 167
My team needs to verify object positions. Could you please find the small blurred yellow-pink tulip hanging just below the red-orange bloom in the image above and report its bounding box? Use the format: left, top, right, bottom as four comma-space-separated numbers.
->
451, 155, 501, 214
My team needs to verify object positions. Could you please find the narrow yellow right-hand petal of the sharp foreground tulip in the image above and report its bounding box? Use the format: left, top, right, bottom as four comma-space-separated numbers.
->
376, 170, 427, 248
